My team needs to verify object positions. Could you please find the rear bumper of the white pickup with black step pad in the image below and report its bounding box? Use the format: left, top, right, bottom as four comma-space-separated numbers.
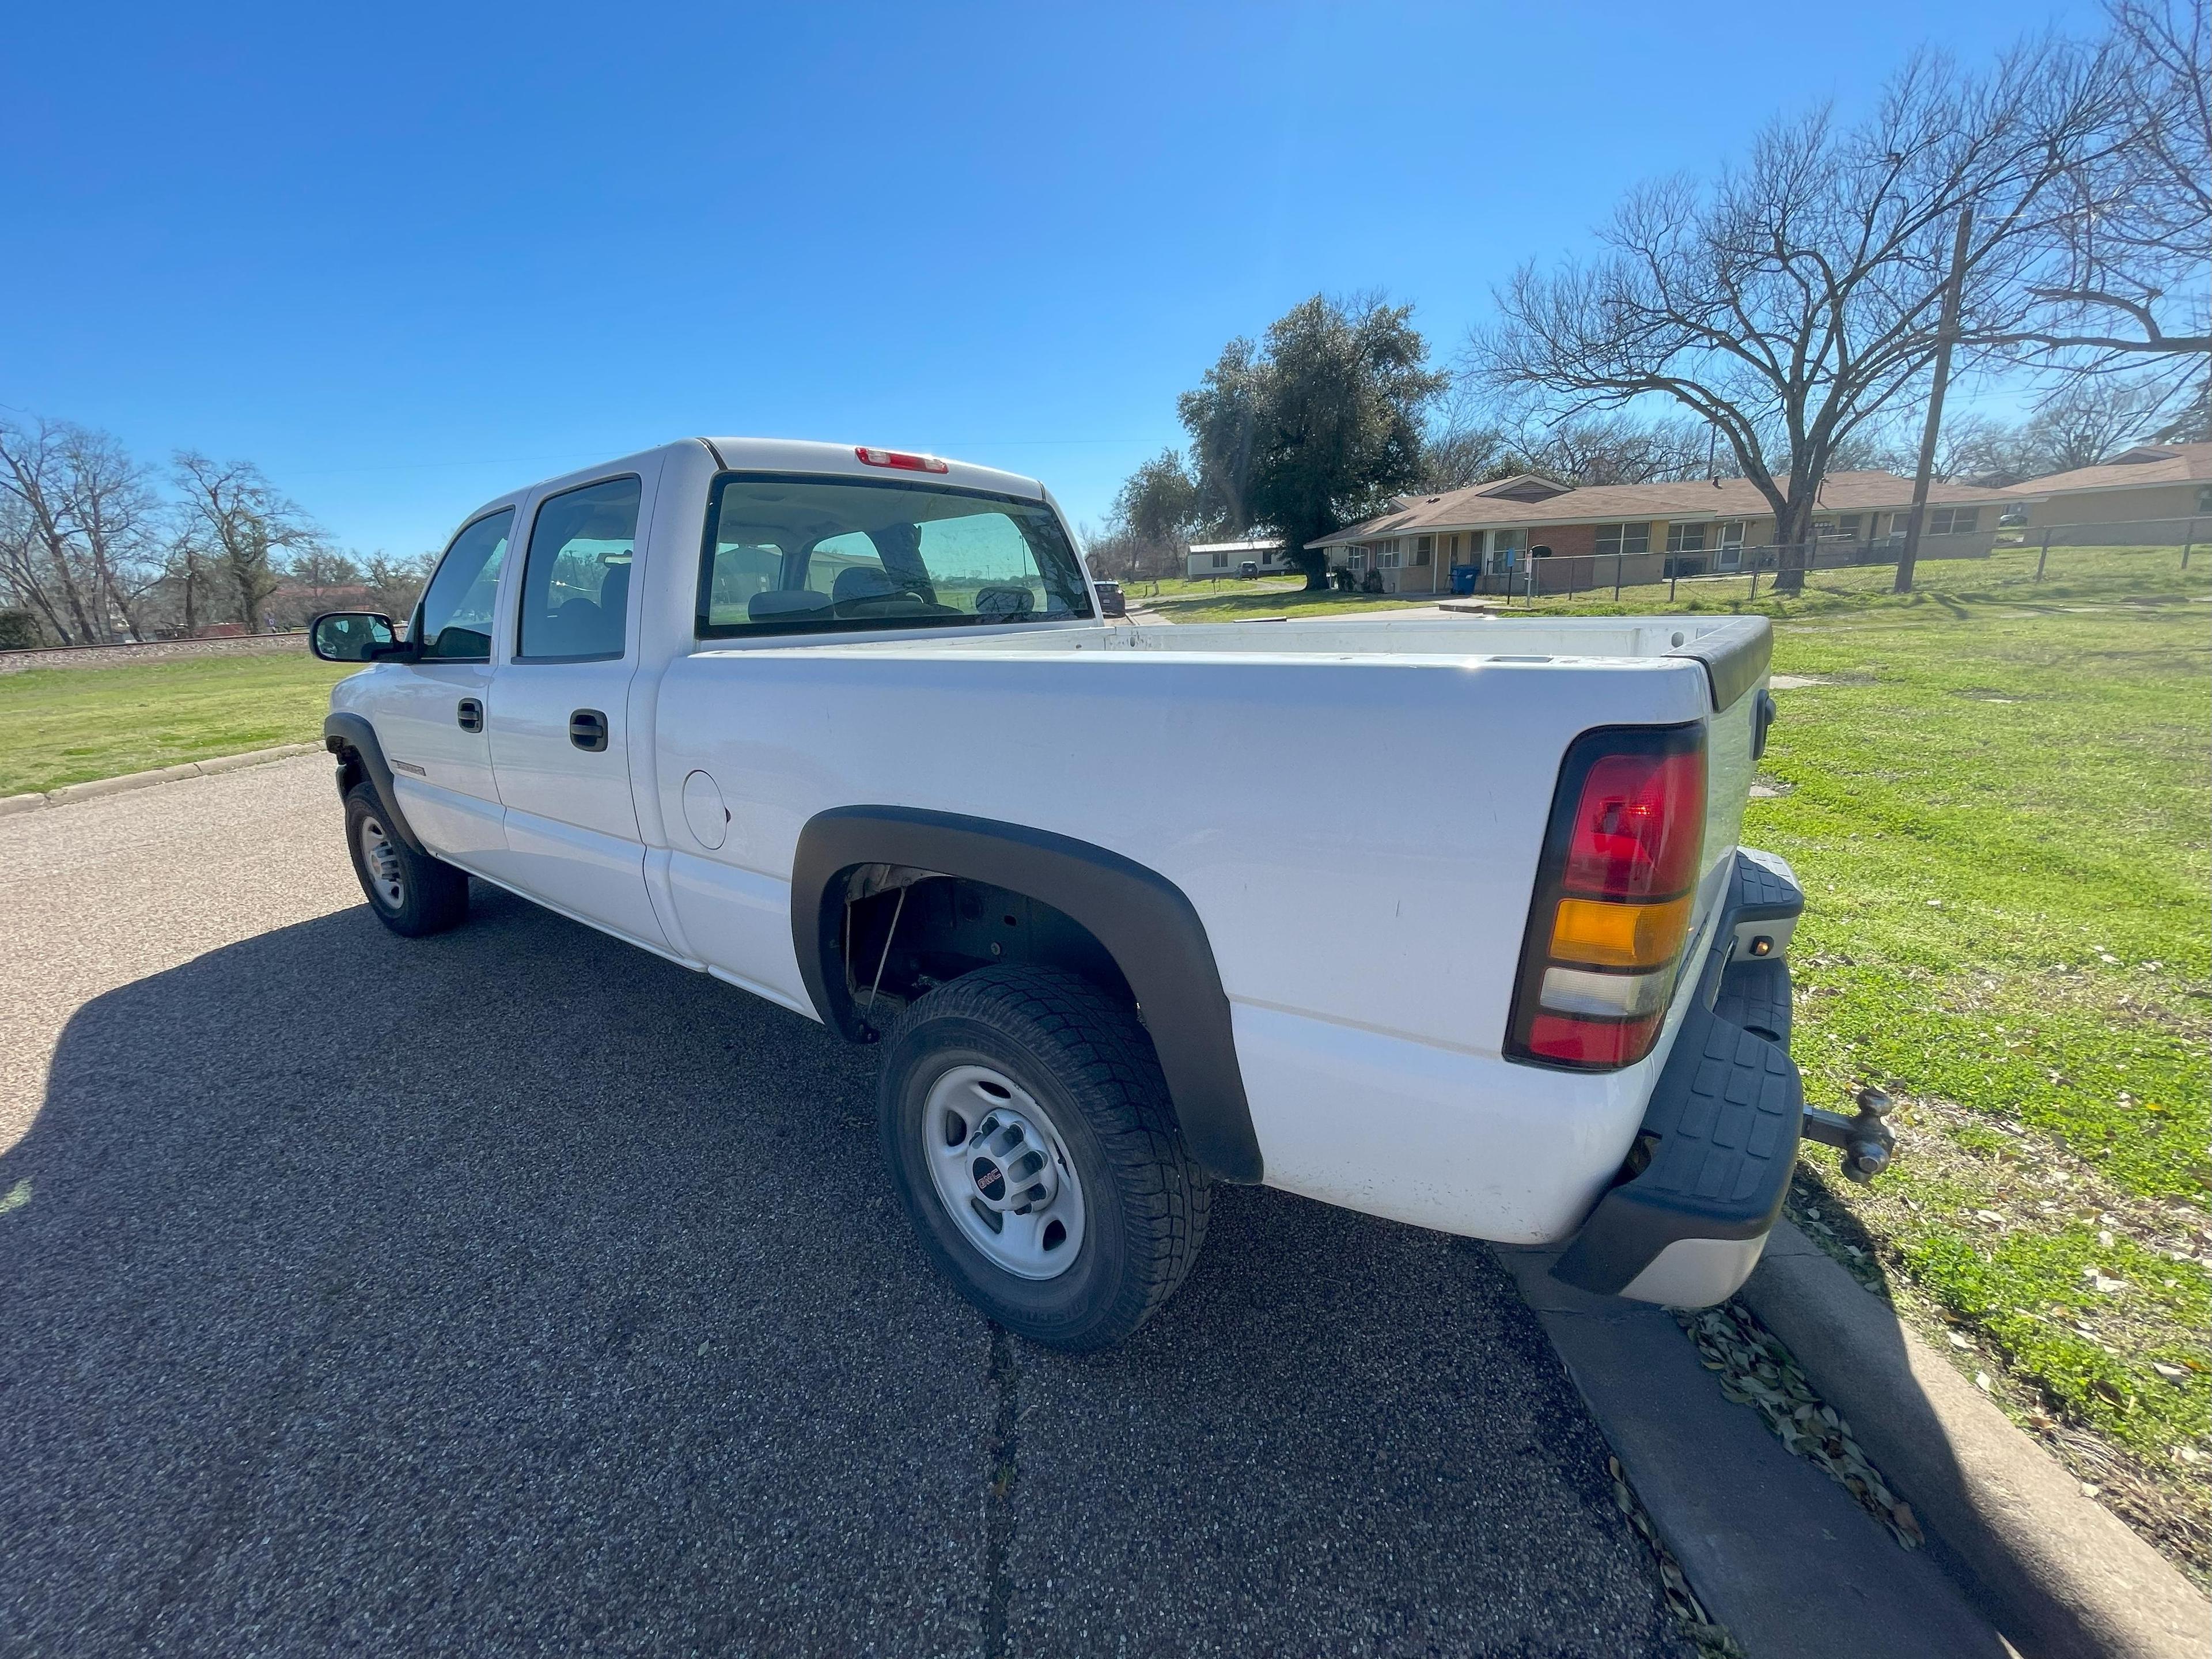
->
1553, 851, 1805, 1307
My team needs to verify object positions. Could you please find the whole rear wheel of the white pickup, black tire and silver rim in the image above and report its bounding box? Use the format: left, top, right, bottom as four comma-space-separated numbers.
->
878, 967, 1208, 1349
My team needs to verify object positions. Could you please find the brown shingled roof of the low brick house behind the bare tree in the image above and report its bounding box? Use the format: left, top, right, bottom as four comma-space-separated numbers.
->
1307, 471, 2013, 546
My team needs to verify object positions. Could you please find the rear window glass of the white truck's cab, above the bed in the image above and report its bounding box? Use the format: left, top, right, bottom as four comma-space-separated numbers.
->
699, 474, 1090, 639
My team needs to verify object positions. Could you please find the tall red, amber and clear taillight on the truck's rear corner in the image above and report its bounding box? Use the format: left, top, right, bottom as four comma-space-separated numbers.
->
1506, 724, 1706, 1071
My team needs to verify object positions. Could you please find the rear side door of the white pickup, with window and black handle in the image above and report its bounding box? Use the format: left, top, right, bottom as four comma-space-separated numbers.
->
491, 469, 666, 949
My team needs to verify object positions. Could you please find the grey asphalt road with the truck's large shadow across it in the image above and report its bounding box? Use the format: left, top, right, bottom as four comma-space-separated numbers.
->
0, 756, 1683, 1654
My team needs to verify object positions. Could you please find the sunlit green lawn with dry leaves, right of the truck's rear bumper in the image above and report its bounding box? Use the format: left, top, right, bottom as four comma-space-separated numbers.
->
1745, 601, 2212, 1570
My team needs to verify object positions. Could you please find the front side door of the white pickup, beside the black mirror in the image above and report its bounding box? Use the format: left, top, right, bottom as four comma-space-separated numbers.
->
376, 506, 516, 867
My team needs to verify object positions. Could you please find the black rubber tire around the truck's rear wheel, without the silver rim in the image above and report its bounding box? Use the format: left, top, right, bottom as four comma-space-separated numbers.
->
876, 967, 1208, 1349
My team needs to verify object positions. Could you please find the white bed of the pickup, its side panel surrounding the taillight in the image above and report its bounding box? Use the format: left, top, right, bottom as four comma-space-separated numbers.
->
655, 617, 1770, 1243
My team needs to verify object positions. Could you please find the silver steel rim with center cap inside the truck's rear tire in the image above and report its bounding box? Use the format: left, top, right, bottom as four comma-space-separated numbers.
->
922, 1066, 1084, 1279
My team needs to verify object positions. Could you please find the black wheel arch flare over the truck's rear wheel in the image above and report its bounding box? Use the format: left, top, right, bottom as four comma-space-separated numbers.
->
792, 805, 1263, 1183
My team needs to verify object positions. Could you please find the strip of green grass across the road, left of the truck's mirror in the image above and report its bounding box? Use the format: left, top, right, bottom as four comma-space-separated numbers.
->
0, 650, 347, 794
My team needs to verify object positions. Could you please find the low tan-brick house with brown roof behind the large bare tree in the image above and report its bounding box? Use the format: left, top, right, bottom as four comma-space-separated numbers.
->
1309, 471, 2017, 593
